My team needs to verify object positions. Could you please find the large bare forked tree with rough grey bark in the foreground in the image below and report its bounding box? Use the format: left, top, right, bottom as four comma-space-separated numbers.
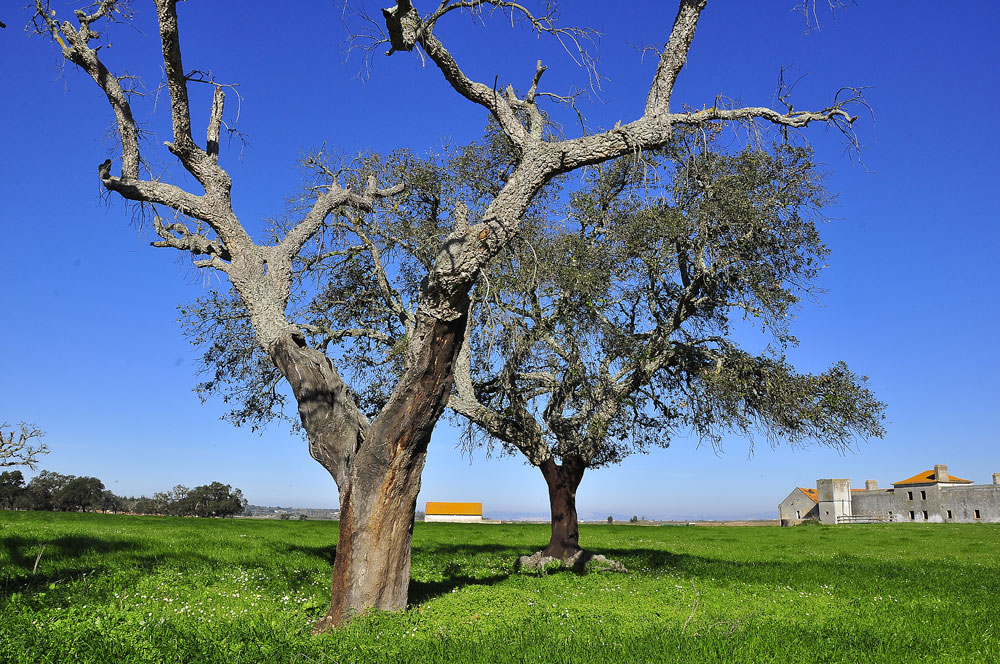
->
34, 0, 854, 630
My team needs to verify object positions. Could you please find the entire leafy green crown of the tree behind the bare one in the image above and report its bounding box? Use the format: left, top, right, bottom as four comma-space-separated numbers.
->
181, 127, 884, 478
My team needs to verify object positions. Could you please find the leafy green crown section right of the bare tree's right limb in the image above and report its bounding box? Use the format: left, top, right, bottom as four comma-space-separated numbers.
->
460, 129, 884, 468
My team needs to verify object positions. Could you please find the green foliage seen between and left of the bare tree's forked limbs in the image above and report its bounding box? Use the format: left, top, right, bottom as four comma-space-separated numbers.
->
180, 128, 544, 422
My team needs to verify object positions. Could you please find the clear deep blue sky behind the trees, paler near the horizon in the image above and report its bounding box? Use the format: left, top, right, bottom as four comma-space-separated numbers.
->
0, 0, 1000, 518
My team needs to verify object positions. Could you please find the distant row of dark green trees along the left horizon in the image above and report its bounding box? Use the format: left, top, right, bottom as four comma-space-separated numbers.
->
0, 470, 247, 517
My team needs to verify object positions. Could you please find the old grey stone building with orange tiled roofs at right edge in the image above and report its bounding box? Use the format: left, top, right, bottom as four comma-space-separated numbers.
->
778, 465, 1000, 526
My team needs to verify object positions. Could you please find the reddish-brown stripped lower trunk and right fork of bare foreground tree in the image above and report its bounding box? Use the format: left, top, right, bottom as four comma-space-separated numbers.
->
292, 308, 466, 632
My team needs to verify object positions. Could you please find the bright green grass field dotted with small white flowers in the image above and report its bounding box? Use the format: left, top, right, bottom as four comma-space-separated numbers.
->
0, 512, 1000, 664
